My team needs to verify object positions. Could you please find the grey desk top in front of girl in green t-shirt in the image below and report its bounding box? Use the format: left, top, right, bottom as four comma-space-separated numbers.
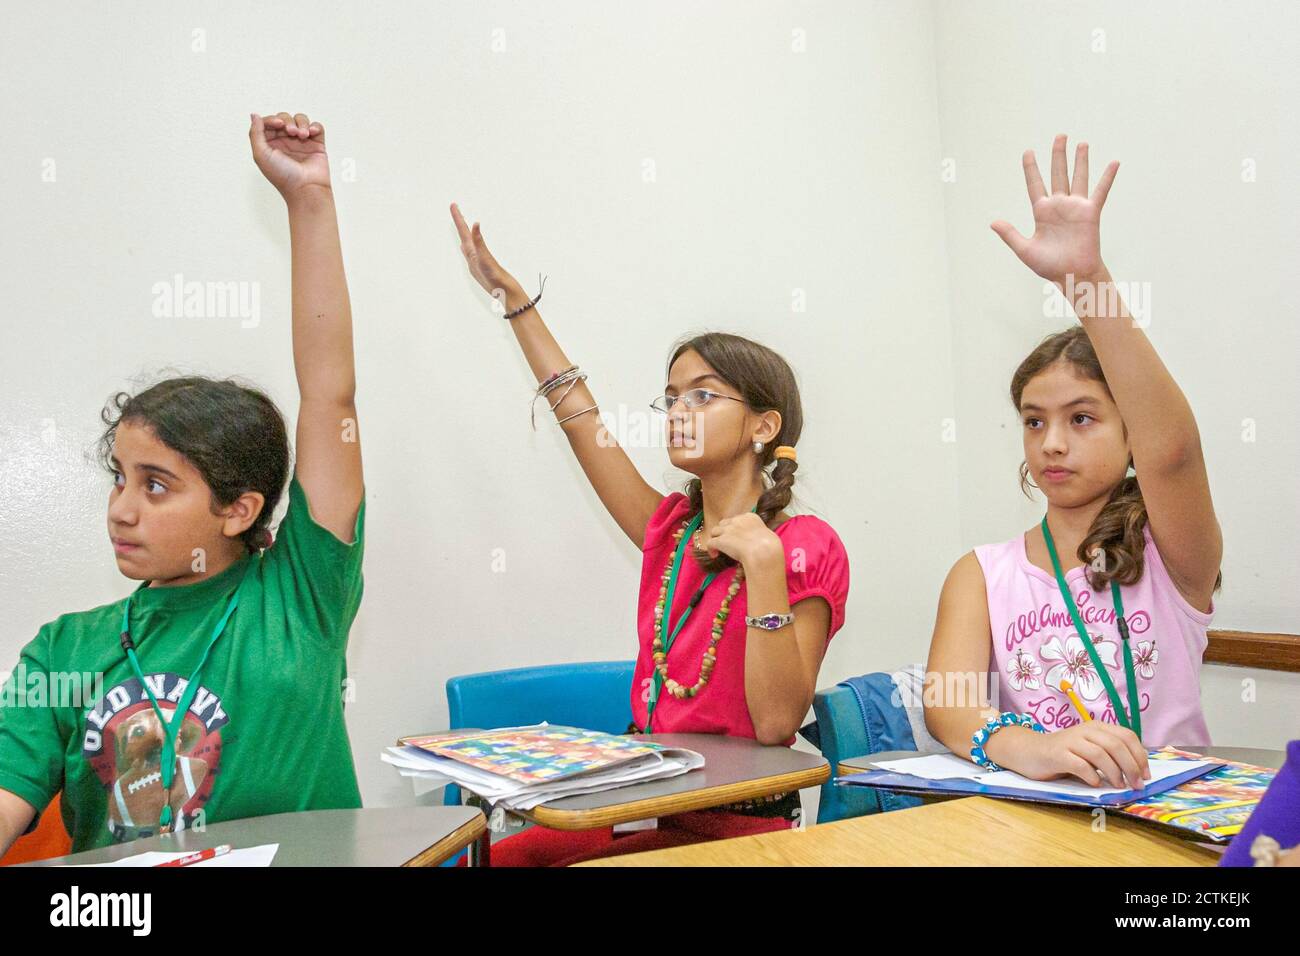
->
22, 806, 486, 866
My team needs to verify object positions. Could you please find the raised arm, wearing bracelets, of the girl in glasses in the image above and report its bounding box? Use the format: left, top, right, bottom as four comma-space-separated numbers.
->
451, 203, 663, 548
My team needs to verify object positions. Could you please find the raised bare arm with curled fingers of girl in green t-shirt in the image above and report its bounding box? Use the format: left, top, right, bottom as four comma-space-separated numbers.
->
248, 113, 363, 544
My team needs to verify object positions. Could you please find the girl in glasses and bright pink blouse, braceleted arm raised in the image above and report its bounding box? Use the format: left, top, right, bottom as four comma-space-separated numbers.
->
451, 204, 849, 866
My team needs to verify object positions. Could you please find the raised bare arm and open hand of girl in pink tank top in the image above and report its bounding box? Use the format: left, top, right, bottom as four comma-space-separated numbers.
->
993, 135, 1223, 609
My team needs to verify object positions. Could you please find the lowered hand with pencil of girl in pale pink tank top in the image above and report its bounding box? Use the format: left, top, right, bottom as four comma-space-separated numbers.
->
1008, 721, 1151, 790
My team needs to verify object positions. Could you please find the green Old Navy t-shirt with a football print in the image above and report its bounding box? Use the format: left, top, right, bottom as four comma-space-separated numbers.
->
0, 475, 365, 851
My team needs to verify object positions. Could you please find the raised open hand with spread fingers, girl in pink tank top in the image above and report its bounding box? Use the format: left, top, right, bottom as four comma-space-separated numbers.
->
992, 133, 1119, 286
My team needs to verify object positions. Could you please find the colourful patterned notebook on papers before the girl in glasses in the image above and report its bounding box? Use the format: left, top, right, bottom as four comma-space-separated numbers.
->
399, 726, 666, 783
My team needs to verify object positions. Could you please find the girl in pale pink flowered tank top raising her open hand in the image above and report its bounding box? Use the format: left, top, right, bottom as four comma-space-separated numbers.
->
926, 137, 1223, 787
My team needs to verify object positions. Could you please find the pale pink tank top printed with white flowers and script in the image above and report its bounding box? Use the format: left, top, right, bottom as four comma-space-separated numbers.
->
975, 527, 1214, 748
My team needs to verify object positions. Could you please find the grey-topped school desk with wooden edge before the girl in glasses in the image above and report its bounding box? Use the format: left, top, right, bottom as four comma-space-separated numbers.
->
436, 734, 831, 866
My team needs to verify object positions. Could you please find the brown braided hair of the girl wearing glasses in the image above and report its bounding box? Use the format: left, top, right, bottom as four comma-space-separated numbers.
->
666, 332, 803, 571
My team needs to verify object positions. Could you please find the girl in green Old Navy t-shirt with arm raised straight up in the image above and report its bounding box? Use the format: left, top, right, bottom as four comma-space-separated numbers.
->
0, 113, 365, 853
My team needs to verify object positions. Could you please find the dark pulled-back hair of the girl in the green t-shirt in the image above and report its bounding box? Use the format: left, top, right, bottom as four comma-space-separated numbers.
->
98, 376, 289, 551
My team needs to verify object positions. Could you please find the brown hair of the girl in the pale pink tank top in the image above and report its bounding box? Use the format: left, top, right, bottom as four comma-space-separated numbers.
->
1011, 325, 1223, 591
